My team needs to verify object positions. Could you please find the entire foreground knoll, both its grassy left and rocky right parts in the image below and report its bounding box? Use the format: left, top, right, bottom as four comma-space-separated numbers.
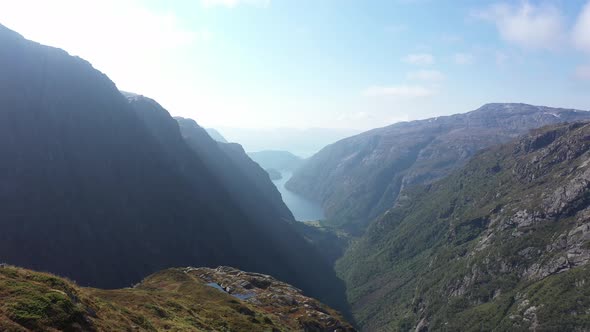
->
0, 266, 354, 332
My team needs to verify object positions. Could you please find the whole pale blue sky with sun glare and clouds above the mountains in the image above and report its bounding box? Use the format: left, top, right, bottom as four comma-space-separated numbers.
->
0, 0, 590, 129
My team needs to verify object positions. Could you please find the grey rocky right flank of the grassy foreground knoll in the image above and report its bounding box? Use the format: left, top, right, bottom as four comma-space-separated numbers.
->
184, 266, 355, 332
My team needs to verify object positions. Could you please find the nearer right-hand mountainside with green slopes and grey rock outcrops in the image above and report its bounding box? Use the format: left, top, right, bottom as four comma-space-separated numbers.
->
337, 122, 590, 331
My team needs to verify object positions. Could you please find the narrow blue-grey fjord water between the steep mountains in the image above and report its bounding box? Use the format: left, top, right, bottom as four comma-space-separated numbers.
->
273, 171, 324, 221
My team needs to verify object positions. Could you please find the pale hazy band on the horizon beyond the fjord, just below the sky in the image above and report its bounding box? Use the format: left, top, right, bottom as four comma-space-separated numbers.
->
219, 127, 360, 157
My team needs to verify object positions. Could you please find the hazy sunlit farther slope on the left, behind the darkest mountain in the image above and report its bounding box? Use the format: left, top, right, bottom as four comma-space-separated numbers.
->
128, 95, 348, 313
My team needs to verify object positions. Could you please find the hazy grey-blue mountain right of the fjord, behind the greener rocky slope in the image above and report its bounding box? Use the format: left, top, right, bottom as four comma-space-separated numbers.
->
286, 104, 590, 233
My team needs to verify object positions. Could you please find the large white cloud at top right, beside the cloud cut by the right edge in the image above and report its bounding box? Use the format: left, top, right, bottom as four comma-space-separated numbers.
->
474, 1, 565, 49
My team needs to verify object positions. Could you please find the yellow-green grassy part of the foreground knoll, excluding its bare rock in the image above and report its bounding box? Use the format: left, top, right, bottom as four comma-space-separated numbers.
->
0, 266, 346, 332
